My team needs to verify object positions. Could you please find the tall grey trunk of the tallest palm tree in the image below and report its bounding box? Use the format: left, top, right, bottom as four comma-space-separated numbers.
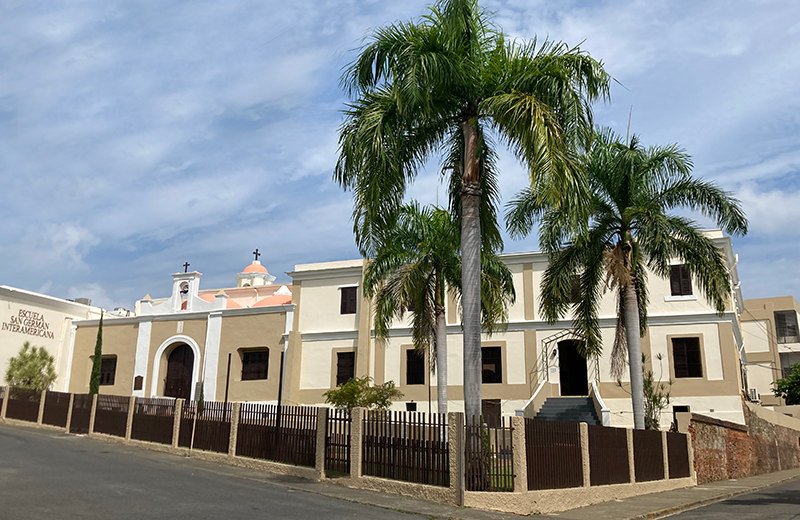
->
461, 118, 481, 420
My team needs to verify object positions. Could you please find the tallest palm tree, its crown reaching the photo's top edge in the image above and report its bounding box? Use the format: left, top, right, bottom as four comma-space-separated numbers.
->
334, 0, 609, 416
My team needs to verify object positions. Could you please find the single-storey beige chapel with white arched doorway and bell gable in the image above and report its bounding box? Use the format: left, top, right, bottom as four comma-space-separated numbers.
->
67, 260, 294, 402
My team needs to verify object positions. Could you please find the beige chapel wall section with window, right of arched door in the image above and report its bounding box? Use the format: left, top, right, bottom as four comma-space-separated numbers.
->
214, 313, 286, 402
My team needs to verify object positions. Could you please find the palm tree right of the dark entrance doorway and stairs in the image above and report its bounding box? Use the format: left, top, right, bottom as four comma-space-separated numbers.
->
506, 130, 747, 429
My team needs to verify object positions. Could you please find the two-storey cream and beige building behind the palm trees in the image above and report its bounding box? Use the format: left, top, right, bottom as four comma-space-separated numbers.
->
286, 231, 744, 426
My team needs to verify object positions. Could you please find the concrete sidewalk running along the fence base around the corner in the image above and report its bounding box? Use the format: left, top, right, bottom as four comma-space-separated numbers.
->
3, 424, 800, 520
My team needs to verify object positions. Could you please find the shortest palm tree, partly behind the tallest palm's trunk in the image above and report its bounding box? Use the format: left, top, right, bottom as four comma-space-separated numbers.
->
364, 204, 514, 413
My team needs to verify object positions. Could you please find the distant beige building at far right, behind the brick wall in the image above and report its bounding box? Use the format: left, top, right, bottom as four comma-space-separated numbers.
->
742, 296, 800, 406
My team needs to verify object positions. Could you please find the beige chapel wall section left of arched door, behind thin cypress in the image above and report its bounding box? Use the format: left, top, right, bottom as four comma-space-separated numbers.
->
69, 321, 139, 395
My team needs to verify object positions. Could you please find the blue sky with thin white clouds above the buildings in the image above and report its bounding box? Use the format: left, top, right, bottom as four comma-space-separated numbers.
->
0, 0, 800, 308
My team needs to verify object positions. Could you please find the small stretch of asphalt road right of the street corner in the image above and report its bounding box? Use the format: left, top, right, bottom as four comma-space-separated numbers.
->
669, 480, 800, 520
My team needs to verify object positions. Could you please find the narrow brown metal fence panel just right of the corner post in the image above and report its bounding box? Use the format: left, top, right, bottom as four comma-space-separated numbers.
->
464, 416, 514, 491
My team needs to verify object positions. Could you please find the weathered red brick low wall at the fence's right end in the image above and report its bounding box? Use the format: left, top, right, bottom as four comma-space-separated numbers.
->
689, 402, 800, 484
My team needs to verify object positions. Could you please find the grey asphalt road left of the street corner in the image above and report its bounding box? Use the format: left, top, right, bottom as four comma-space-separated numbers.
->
0, 426, 420, 520
